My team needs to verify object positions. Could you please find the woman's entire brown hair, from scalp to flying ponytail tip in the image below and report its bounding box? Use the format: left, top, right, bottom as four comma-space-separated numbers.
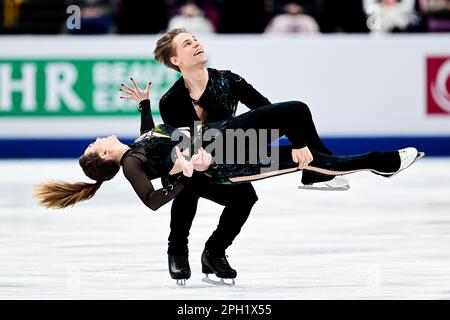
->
34, 153, 120, 209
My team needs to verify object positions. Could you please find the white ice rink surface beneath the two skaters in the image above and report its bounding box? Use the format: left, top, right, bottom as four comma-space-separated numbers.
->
0, 158, 450, 300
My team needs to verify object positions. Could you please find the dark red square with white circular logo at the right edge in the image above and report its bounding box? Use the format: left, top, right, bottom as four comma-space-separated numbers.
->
427, 56, 450, 115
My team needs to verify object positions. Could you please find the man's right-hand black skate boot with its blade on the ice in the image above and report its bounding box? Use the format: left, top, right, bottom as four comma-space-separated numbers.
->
201, 249, 237, 285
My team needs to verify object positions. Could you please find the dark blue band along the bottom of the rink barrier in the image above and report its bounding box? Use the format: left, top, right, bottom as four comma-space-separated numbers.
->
0, 136, 450, 159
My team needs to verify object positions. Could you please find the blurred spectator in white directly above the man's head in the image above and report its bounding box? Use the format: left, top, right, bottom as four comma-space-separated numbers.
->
167, 2, 215, 34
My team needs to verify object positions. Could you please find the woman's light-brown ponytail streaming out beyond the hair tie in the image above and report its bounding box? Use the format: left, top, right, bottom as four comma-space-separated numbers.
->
33, 180, 102, 209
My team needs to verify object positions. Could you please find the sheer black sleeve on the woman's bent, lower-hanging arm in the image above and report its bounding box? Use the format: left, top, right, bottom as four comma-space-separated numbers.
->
123, 155, 190, 211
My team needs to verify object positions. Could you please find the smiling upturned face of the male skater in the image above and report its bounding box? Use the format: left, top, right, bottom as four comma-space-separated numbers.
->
170, 33, 208, 70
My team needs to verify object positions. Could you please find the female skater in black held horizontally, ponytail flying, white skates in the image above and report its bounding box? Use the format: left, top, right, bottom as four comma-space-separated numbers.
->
35, 84, 423, 279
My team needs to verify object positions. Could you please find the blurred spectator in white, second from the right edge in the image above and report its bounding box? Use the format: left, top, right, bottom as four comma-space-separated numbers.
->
364, 0, 415, 32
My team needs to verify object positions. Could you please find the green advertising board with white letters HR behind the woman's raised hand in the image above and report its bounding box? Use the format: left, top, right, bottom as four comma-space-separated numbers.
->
0, 58, 180, 117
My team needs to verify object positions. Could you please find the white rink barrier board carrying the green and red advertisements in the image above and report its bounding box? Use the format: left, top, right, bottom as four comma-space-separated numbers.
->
0, 34, 450, 139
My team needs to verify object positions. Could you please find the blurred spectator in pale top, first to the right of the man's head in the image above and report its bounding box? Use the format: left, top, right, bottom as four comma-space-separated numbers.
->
265, 1, 320, 34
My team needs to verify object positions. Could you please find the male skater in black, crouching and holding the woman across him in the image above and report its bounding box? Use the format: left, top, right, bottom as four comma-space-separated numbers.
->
154, 29, 347, 280
